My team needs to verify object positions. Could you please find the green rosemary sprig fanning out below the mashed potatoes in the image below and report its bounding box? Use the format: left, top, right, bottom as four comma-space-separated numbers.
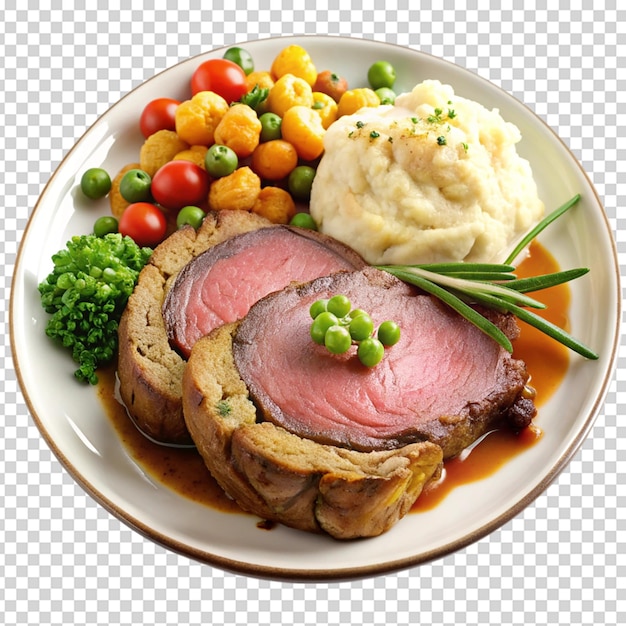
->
377, 194, 598, 359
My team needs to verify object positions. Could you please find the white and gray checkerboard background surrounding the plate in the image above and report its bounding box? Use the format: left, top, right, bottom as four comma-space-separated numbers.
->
0, 0, 626, 626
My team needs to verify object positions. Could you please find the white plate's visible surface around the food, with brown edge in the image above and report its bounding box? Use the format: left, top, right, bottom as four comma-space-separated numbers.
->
11, 37, 621, 580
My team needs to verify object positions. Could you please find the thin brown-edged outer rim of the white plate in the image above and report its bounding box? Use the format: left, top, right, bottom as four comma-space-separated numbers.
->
9, 35, 623, 582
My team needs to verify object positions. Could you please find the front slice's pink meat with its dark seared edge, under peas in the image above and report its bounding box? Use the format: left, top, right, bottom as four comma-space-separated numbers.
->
233, 268, 535, 458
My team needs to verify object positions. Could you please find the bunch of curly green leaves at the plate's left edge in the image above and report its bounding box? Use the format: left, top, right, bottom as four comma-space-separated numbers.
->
39, 233, 152, 385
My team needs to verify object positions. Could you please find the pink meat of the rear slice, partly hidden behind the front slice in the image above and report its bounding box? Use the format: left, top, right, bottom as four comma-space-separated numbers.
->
162, 226, 366, 358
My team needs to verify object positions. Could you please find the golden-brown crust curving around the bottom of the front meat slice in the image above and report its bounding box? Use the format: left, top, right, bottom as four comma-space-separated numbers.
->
183, 322, 442, 539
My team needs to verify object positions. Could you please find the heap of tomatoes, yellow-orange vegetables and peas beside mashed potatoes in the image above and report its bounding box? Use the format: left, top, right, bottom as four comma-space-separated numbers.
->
81, 44, 395, 247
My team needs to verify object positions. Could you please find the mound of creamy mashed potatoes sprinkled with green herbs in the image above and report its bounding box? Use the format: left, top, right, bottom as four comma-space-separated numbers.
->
310, 80, 544, 264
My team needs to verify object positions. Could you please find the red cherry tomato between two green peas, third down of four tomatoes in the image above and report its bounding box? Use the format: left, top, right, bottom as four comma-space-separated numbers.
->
151, 159, 209, 210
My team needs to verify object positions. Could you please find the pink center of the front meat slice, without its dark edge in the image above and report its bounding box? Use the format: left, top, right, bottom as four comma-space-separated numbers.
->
239, 291, 500, 444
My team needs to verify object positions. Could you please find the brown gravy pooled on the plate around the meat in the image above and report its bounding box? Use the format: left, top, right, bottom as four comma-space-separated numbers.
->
98, 243, 570, 513
